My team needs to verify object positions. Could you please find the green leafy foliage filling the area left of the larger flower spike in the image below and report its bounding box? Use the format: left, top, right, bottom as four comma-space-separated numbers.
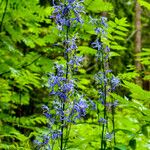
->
0, 0, 54, 150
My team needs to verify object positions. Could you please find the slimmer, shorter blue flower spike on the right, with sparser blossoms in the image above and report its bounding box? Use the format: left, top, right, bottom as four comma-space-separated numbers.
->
90, 14, 120, 149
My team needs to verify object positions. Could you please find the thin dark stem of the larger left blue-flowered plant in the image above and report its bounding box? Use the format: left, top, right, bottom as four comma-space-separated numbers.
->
60, 26, 69, 150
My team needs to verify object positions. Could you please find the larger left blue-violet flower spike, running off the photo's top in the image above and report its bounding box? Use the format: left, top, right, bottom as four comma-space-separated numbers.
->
35, 0, 91, 150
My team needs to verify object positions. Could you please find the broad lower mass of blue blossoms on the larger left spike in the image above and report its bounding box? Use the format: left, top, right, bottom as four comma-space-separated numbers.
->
36, 64, 90, 148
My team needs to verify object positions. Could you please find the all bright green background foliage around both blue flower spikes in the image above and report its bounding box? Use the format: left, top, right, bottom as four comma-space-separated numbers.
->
0, 0, 150, 150
